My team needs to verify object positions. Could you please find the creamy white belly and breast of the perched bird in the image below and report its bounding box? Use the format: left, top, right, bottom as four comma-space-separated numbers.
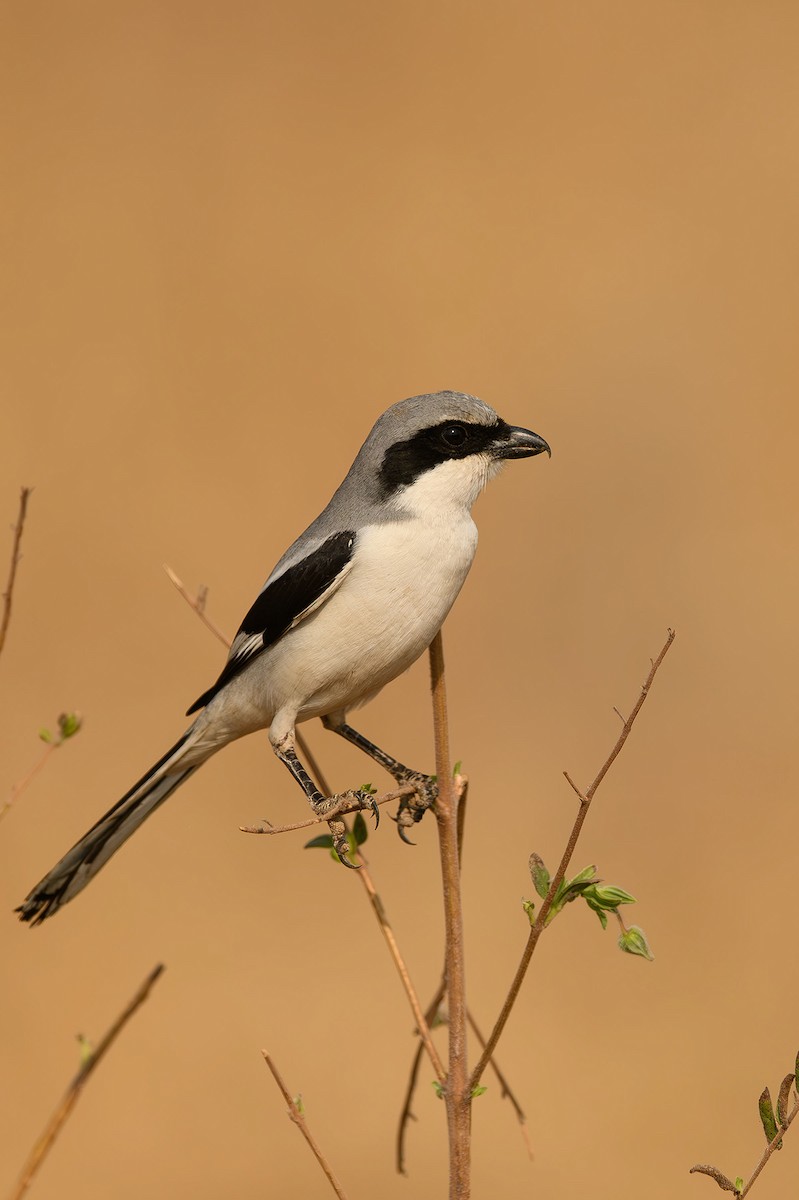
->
248, 516, 477, 724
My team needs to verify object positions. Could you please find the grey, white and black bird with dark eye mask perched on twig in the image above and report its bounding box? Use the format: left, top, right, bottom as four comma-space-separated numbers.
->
17, 391, 551, 925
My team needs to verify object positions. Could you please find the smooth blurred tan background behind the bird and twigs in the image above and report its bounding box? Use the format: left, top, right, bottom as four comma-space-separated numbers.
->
0, 0, 799, 1200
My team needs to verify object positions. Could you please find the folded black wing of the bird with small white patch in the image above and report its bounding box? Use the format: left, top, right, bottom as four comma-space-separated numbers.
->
186, 529, 355, 716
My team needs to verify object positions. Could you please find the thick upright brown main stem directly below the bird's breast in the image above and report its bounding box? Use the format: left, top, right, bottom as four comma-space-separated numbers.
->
429, 631, 471, 1200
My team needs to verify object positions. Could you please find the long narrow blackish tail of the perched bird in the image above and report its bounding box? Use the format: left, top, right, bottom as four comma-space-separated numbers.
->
17, 726, 203, 925
